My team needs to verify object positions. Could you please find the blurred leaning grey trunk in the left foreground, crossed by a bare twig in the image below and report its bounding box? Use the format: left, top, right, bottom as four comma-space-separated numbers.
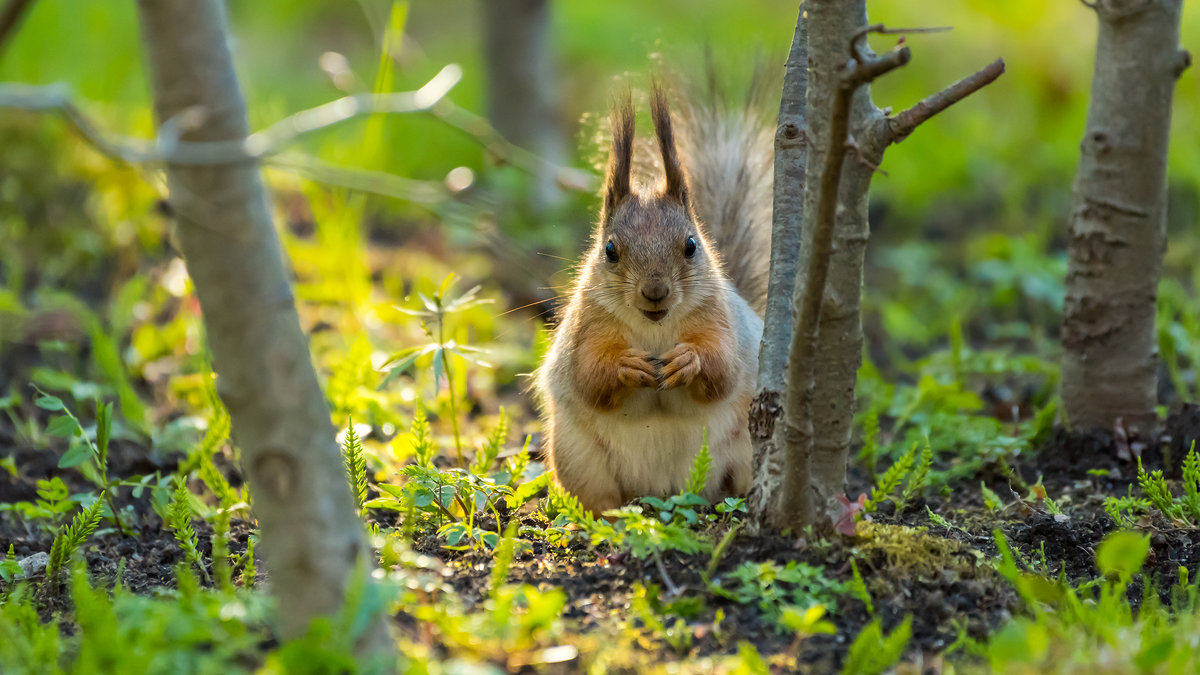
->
138, 0, 386, 650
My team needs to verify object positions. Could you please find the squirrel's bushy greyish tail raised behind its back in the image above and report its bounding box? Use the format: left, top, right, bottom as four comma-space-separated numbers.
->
676, 74, 774, 315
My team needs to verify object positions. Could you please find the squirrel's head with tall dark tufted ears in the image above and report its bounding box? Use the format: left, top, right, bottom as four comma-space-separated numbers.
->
588, 84, 720, 323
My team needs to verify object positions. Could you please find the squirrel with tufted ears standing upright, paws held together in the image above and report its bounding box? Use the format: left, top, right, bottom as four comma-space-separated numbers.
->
535, 83, 773, 514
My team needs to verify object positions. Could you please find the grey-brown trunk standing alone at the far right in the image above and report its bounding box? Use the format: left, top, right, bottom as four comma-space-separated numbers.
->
1062, 0, 1189, 434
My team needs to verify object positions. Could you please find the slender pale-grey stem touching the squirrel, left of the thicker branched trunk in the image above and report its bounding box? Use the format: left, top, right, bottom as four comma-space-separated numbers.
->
748, 8, 809, 524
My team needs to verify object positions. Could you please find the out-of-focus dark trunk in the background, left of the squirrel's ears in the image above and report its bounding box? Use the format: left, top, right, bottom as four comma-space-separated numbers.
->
481, 0, 566, 210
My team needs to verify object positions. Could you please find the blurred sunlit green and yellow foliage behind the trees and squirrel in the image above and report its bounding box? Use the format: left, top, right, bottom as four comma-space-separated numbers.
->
0, 0, 1200, 451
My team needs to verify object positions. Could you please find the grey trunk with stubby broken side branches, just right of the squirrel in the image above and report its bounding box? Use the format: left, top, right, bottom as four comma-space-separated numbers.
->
749, 0, 1004, 527
